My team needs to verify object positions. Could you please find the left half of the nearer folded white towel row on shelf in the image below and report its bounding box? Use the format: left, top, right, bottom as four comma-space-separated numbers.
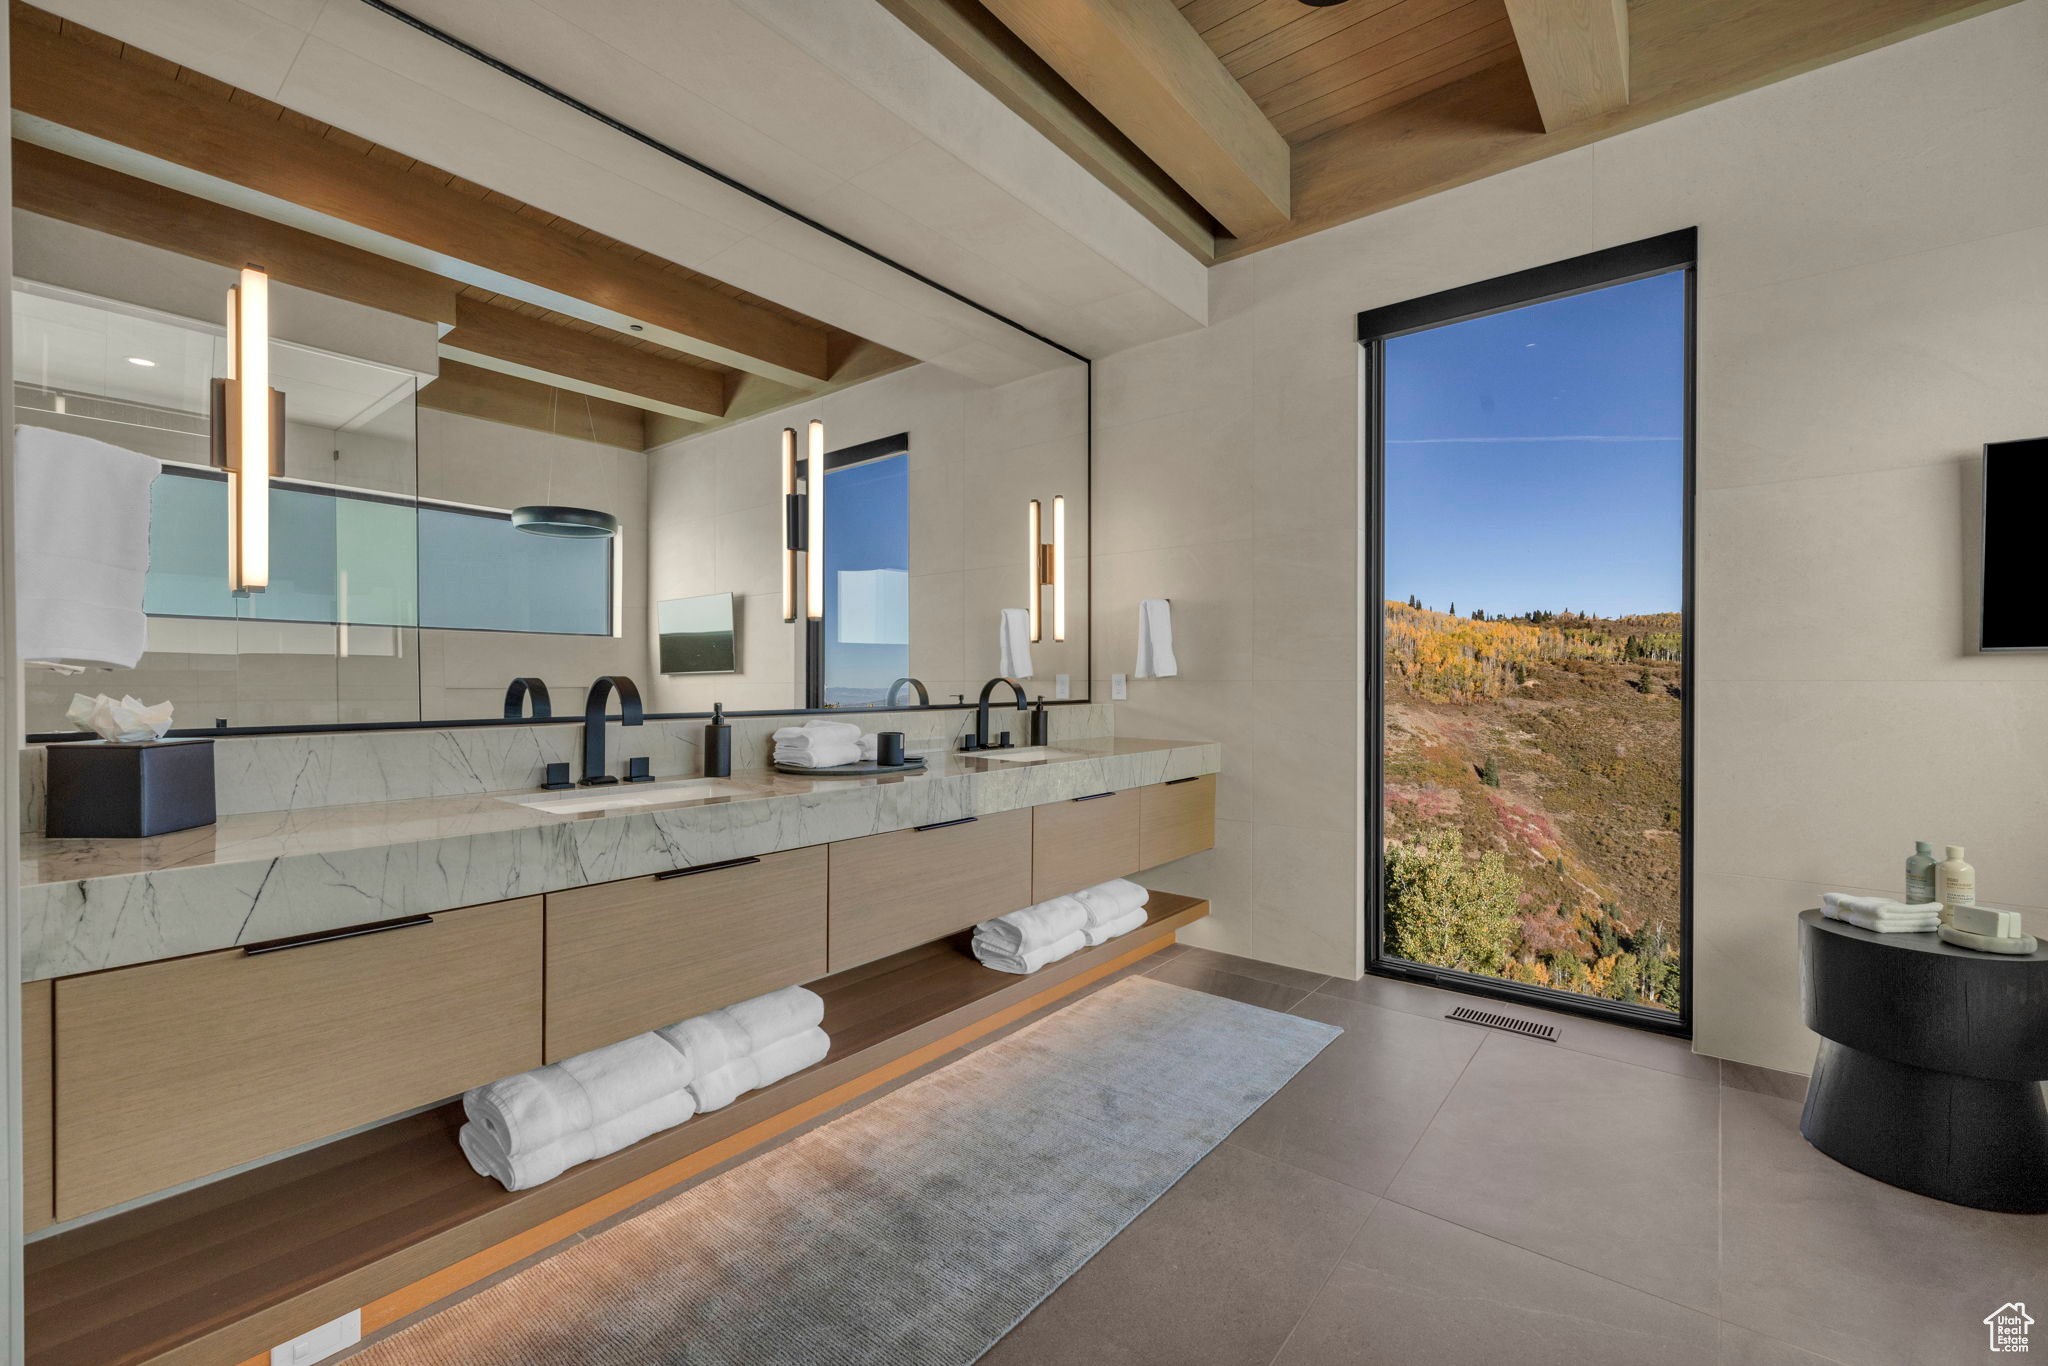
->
457, 1034, 696, 1190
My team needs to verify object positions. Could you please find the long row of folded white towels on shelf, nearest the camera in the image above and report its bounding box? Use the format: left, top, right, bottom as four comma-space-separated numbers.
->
457, 987, 831, 1190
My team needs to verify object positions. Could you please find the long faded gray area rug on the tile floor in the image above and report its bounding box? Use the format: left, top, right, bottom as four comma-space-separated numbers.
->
350, 977, 1341, 1366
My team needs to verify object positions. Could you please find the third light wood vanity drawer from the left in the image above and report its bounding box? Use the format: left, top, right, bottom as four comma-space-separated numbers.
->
831, 807, 1032, 973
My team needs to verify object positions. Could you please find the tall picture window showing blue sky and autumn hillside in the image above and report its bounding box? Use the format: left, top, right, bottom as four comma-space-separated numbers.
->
1360, 233, 1692, 1030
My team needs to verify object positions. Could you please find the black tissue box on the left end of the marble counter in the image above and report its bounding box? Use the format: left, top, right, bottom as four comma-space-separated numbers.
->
43, 739, 215, 840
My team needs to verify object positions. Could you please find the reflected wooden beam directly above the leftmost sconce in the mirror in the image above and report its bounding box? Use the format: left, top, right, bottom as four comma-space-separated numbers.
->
14, 137, 457, 326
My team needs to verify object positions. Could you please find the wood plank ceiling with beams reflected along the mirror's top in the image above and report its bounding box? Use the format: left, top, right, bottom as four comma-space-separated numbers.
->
10, 0, 911, 446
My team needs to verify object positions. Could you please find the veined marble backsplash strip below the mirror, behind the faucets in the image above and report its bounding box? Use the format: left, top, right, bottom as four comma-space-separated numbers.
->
20, 702, 1116, 834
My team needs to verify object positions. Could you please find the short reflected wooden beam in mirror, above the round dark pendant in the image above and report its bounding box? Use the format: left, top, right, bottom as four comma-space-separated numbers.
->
440, 297, 725, 422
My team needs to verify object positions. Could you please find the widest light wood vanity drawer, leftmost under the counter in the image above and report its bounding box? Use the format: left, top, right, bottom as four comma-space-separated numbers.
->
55, 897, 541, 1219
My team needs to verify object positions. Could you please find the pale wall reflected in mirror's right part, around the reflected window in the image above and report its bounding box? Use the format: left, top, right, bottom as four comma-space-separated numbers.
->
647, 365, 1108, 711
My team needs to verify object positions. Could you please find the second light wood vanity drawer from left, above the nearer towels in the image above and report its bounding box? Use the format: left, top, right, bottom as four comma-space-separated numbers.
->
547, 844, 825, 1063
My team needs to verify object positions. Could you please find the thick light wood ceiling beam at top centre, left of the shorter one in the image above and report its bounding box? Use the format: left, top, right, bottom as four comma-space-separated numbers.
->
983, 0, 1290, 236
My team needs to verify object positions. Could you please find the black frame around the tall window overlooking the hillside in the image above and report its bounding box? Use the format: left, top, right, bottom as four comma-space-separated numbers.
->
1358, 227, 1700, 1038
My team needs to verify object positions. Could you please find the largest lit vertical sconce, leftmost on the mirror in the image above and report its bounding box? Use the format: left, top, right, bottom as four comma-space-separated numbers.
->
213, 266, 285, 592
